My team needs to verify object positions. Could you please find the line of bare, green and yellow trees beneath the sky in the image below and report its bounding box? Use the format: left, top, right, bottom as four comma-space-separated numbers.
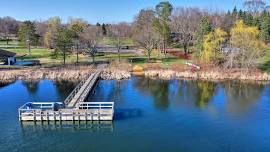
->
0, 0, 270, 68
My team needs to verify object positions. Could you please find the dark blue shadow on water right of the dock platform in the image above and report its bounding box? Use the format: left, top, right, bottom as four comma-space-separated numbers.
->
114, 108, 143, 120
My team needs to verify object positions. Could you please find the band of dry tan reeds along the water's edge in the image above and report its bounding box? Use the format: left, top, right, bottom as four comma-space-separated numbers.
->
0, 62, 270, 83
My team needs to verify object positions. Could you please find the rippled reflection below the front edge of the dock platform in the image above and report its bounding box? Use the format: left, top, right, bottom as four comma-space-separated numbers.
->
21, 121, 114, 133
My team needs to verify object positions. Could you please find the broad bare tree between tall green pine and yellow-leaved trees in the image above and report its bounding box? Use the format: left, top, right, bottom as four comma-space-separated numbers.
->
170, 7, 203, 54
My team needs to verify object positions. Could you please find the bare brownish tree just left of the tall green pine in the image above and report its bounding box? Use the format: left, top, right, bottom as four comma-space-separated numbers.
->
133, 10, 159, 61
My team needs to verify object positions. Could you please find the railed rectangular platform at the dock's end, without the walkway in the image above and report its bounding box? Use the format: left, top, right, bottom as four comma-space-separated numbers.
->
19, 102, 114, 121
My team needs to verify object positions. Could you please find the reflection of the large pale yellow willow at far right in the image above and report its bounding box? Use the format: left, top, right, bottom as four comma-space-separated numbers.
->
224, 82, 264, 112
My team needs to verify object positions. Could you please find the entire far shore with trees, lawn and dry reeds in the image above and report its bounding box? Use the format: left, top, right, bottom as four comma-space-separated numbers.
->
0, 0, 270, 83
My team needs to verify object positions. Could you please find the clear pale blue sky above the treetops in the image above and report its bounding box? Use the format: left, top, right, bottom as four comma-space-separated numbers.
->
0, 0, 270, 23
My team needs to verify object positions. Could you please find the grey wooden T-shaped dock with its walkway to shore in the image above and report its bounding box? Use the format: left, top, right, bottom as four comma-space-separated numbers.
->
18, 68, 114, 121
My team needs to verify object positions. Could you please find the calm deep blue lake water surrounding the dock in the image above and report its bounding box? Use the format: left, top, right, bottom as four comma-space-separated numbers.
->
0, 77, 270, 152
